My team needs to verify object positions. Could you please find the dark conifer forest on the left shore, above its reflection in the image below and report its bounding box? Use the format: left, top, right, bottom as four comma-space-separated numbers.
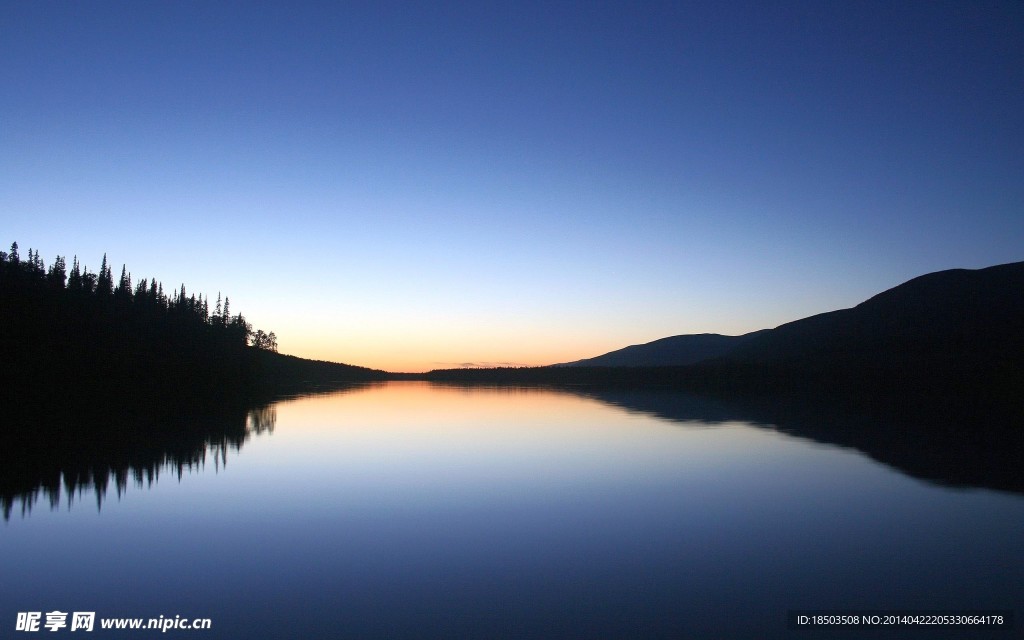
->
0, 242, 276, 411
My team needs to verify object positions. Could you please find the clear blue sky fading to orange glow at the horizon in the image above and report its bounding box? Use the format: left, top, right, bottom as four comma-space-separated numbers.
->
0, 0, 1024, 372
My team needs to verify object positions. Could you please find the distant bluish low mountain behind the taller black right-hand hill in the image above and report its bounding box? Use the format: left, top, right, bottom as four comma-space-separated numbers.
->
556, 331, 764, 367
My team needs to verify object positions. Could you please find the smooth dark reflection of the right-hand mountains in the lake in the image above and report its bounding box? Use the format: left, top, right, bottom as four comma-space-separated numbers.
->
571, 388, 1024, 494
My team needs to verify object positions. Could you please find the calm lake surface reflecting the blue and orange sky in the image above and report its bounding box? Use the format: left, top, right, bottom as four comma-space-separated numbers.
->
0, 382, 1024, 638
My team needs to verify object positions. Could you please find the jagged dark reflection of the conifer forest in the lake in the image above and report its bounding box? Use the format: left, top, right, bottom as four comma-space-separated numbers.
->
0, 406, 276, 521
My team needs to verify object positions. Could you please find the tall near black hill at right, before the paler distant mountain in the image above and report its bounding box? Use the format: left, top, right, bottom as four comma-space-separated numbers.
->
727, 262, 1024, 383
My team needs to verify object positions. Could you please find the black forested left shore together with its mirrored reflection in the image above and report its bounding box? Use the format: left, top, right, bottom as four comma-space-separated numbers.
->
0, 243, 386, 519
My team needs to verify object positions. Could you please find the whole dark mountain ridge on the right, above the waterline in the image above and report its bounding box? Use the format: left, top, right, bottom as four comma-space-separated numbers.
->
564, 262, 1024, 375
